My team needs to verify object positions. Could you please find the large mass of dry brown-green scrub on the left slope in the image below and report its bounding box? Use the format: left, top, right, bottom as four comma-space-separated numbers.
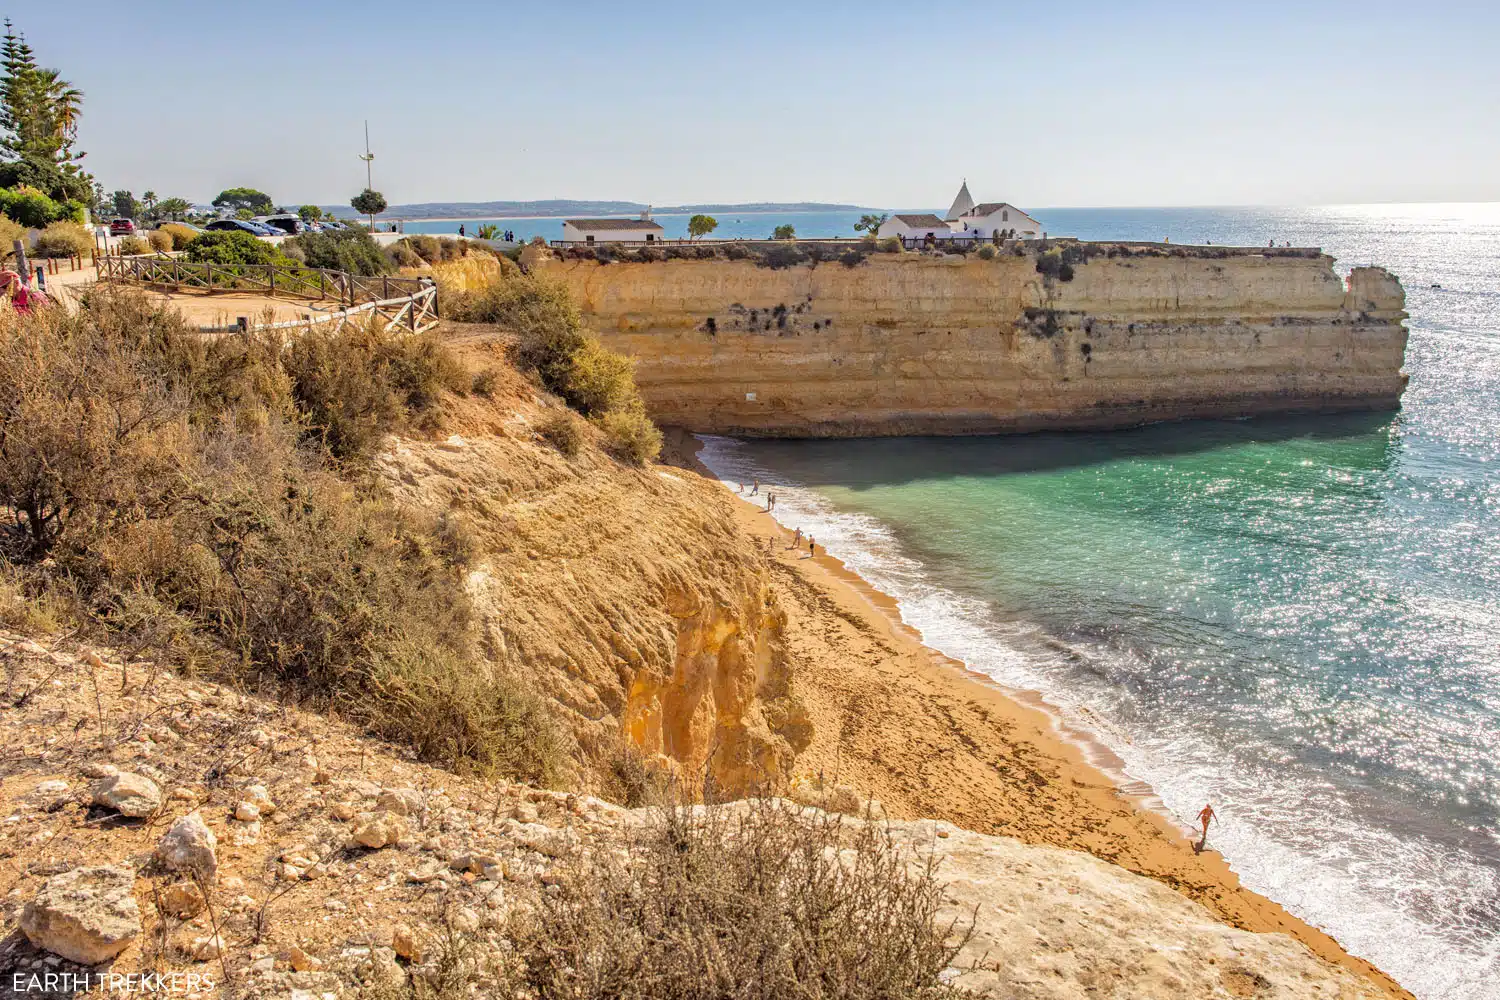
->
0, 286, 567, 783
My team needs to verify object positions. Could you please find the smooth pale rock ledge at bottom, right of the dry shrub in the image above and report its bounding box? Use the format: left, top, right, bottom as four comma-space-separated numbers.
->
888, 820, 1388, 1000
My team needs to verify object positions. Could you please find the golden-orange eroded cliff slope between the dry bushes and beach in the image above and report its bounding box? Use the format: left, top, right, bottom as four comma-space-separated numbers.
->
367, 353, 810, 792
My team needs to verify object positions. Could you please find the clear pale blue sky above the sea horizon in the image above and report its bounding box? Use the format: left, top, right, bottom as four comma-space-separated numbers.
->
23, 0, 1500, 207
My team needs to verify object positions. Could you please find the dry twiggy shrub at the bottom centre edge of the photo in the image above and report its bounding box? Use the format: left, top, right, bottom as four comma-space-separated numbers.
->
495, 801, 972, 1000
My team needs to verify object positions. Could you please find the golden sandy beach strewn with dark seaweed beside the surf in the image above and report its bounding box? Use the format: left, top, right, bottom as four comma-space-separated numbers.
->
668, 429, 1412, 997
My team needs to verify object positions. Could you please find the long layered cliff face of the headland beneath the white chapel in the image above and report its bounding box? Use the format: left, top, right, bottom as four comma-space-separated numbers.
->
533, 249, 1407, 436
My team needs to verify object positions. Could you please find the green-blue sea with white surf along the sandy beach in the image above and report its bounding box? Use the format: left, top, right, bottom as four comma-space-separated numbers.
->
702, 204, 1500, 1000
